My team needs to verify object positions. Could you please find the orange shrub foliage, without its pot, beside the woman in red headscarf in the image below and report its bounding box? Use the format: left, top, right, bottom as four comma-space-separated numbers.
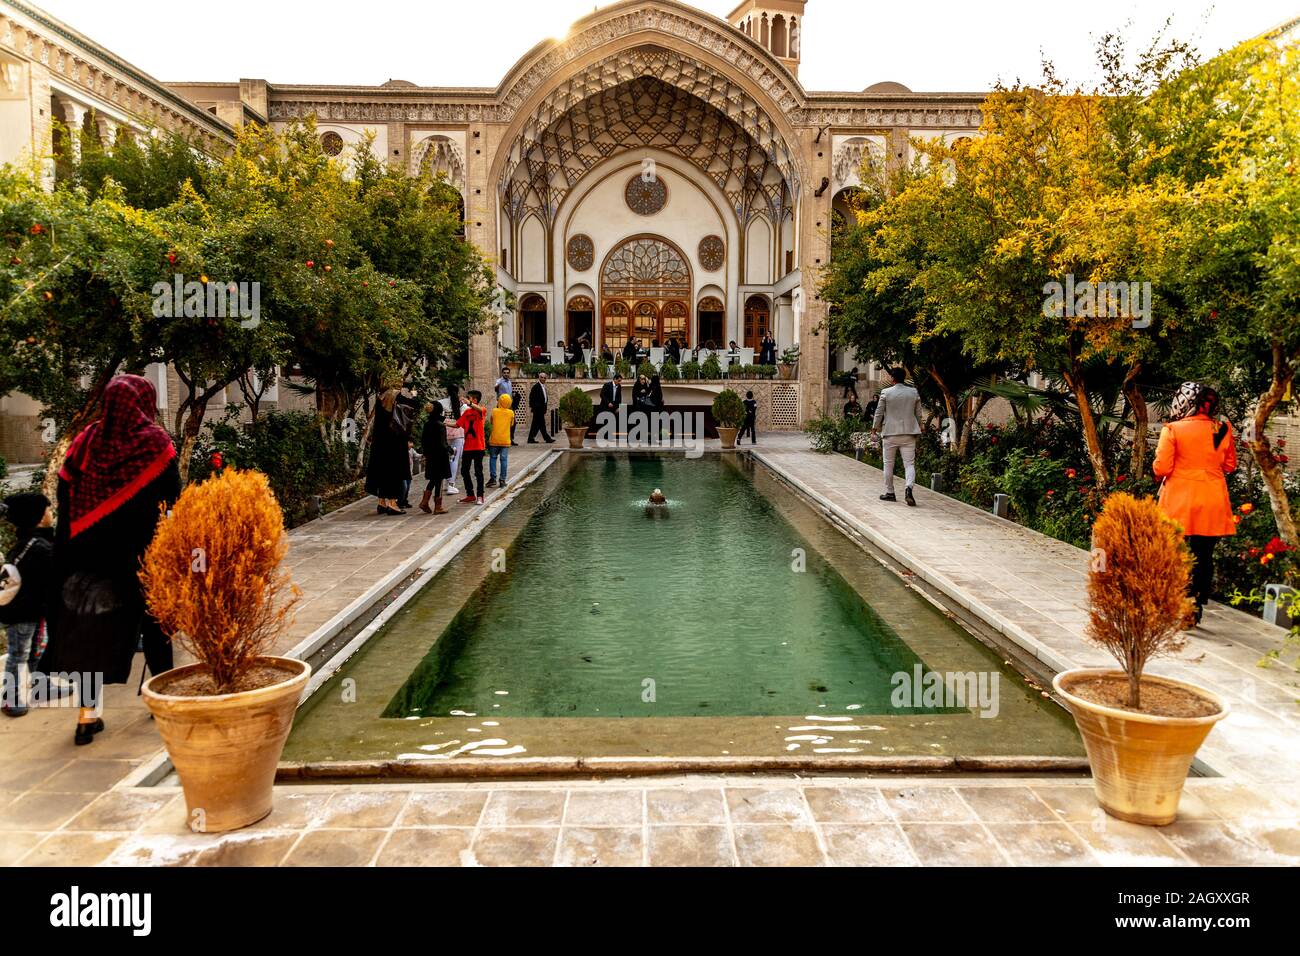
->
140, 468, 298, 693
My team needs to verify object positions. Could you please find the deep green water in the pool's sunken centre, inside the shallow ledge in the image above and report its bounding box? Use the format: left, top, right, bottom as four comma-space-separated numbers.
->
384, 455, 956, 717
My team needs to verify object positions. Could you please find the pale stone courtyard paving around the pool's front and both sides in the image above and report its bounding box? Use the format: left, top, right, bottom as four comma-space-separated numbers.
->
0, 434, 1300, 866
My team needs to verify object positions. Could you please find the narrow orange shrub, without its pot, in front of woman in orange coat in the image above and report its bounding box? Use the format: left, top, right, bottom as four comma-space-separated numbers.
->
1088, 493, 1195, 709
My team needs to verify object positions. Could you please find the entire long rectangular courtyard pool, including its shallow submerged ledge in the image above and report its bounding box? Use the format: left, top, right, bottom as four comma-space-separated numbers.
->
285, 453, 1083, 762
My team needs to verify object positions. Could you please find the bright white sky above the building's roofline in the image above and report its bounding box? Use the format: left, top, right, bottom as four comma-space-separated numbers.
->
35, 0, 1300, 92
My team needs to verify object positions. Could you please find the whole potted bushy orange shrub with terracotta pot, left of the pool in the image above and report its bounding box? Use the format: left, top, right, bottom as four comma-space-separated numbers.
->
140, 468, 312, 832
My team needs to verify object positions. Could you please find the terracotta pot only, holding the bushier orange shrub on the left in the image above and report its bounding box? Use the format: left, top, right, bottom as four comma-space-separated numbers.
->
144, 657, 312, 832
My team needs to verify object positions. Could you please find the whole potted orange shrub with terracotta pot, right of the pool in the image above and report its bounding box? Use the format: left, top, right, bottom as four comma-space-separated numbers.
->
1053, 493, 1227, 826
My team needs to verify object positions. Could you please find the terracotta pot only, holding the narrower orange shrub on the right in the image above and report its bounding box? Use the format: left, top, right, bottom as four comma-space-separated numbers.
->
1052, 667, 1229, 826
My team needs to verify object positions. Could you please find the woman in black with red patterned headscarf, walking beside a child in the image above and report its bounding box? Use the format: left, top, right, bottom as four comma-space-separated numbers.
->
42, 375, 181, 744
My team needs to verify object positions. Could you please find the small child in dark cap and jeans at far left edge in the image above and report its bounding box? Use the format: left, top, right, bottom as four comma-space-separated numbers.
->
0, 493, 55, 717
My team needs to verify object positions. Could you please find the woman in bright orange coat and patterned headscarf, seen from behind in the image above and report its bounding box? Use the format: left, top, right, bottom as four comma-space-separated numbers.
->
1153, 382, 1236, 624
